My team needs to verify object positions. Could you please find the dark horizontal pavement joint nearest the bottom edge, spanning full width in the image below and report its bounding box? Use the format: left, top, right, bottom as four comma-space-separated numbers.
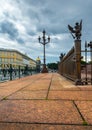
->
0, 121, 92, 126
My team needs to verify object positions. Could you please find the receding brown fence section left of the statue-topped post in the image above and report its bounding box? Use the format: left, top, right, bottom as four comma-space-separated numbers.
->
59, 47, 77, 80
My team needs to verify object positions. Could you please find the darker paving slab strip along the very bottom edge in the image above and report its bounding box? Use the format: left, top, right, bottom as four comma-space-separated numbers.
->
0, 123, 92, 130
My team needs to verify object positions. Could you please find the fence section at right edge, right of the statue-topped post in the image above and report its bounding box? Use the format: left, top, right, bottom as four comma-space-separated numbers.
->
81, 42, 92, 85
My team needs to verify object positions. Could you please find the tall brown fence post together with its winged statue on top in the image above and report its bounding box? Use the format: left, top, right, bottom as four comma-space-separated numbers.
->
68, 20, 82, 85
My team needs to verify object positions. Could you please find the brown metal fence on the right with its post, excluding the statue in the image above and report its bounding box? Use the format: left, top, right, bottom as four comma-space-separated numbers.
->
58, 40, 92, 85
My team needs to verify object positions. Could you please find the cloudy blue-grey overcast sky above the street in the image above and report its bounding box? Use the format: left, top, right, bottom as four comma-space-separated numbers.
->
0, 0, 92, 63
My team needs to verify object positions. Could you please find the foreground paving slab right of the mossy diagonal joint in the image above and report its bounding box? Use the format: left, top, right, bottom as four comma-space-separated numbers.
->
75, 101, 92, 125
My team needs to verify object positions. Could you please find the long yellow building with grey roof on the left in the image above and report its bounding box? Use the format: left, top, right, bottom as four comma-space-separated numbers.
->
0, 49, 36, 69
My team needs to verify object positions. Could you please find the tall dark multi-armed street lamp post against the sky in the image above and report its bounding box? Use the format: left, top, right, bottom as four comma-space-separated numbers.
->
38, 30, 50, 73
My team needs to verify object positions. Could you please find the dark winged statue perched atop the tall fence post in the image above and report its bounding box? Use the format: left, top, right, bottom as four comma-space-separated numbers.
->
68, 20, 82, 40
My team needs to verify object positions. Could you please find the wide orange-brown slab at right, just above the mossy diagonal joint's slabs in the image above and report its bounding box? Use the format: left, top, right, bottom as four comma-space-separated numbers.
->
48, 91, 92, 100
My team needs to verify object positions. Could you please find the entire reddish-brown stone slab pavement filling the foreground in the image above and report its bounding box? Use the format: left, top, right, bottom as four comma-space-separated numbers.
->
0, 73, 92, 130
